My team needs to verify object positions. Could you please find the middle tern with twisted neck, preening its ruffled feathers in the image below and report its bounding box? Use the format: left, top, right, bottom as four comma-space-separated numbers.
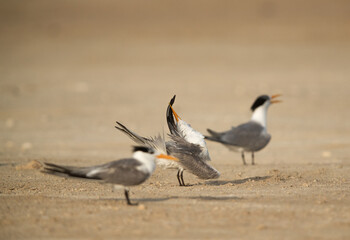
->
115, 96, 220, 186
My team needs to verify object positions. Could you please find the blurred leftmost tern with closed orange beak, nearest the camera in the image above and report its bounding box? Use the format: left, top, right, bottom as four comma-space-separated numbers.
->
45, 146, 178, 205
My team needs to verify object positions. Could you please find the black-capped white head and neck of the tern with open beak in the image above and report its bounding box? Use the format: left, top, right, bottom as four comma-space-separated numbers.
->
250, 94, 281, 128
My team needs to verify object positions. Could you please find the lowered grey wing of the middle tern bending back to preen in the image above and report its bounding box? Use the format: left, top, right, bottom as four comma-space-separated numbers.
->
167, 135, 220, 179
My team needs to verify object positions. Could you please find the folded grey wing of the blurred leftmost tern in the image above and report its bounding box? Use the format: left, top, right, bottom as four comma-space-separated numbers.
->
89, 158, 150, 186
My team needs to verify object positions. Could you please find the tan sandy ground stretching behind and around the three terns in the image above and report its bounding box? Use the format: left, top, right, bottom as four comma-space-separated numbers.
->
0, 1, 350, 239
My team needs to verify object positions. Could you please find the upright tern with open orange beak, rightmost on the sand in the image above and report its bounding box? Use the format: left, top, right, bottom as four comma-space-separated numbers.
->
205, 94, 281, 165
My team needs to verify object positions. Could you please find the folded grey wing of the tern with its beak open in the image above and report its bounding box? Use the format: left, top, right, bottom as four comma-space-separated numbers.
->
221, 122, 271, 151
